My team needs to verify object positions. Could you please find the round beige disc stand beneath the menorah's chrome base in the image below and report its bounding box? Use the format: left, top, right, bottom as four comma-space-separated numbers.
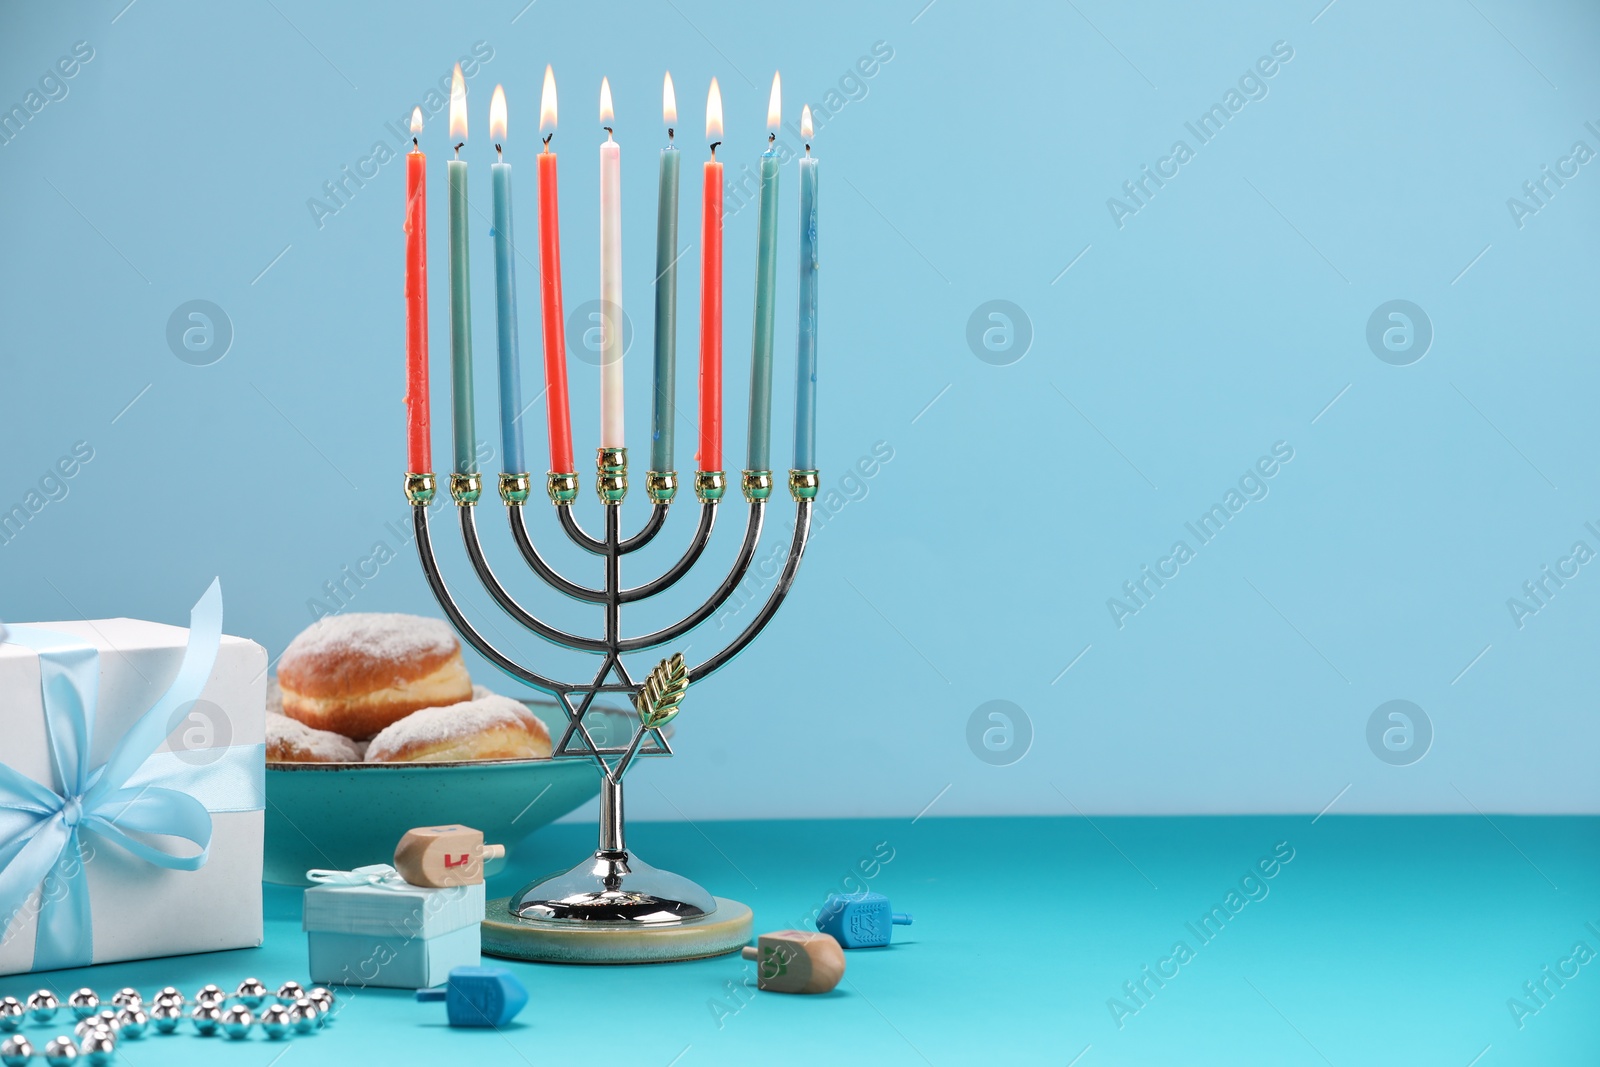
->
483, 889, 754, 963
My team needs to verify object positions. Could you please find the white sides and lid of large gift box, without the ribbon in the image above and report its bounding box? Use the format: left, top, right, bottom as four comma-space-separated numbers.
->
0, 607, 267, 974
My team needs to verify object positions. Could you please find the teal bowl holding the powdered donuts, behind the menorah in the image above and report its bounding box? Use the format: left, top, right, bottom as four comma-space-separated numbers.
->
262, 702, 637, 886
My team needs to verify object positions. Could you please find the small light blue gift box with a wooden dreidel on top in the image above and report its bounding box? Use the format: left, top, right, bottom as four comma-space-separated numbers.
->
301, 865, 485, 989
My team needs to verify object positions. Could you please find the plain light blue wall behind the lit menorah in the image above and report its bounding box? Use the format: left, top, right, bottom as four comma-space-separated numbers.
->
0, 0, 1600, 819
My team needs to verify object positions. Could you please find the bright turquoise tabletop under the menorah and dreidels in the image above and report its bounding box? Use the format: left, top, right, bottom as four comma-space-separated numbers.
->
0, 816, 1600, 1067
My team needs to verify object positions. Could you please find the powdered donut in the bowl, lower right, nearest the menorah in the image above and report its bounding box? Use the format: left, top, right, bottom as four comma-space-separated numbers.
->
366, 693, 550, 763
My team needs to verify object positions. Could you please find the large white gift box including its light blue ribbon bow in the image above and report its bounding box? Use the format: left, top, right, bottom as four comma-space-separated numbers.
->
0, 584, 267, 974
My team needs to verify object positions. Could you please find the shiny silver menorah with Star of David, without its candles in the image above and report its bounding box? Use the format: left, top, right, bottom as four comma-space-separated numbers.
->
405, 460, 819, 944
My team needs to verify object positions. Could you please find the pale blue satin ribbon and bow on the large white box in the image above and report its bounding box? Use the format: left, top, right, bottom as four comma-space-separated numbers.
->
0, 581, 266, 971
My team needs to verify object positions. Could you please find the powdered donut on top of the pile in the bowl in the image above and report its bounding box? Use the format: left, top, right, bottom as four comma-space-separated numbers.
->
278, 613, 472, 741
